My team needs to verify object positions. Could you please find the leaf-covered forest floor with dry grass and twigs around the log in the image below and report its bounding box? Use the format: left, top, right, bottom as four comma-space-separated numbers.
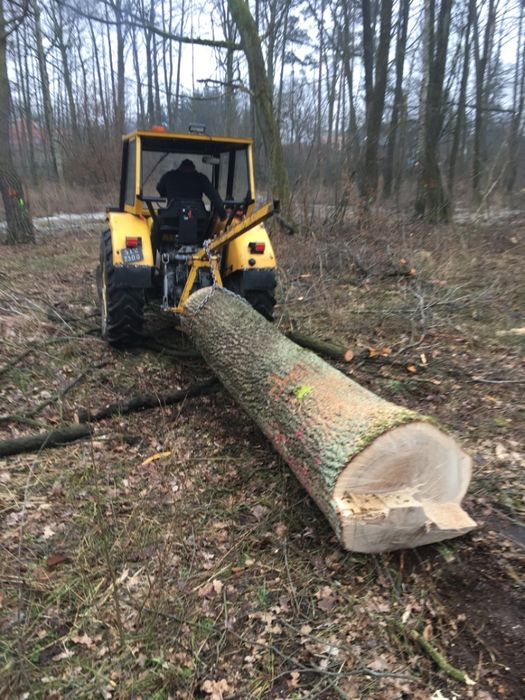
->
0, 211, 525, 700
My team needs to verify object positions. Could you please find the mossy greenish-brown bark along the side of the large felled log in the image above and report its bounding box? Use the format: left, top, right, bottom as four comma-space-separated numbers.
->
184, 289, 474, 548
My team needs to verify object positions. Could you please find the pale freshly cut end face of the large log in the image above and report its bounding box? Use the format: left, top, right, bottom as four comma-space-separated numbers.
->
333, 422, 476, 552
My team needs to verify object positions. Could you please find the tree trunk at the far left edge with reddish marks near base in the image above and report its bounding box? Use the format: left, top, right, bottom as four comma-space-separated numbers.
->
0, 0, 35, 243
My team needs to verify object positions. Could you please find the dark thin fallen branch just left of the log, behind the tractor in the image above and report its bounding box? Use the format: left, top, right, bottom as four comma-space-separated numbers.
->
76, 377, 220, 423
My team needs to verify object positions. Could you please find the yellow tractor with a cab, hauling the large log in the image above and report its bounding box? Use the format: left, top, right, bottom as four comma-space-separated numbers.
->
97, 125, 278, 346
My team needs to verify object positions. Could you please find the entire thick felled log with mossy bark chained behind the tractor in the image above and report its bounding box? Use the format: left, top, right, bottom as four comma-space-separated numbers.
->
184, 289, 475, 552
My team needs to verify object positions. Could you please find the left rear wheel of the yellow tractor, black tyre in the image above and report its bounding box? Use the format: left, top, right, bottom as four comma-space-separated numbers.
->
97, 230, 144, 347
